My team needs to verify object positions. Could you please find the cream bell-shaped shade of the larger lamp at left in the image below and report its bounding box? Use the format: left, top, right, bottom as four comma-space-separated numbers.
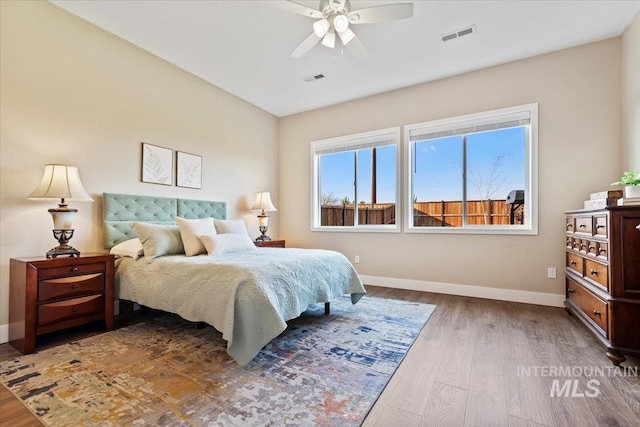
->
28, 165, 93, 202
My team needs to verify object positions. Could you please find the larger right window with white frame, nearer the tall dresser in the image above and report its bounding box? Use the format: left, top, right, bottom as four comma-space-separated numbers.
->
404, 104, 537, 234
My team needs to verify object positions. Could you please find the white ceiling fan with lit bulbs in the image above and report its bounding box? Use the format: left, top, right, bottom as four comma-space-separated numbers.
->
279, 0, 413, 59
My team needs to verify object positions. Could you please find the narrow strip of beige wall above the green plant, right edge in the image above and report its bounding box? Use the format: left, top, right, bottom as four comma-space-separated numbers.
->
622, 13, 640, 171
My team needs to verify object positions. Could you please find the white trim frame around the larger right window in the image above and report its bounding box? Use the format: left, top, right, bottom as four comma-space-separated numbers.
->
403, 103, 538, 235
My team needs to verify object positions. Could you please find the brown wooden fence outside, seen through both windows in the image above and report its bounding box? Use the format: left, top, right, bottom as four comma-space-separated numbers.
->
321, 200, 524, 227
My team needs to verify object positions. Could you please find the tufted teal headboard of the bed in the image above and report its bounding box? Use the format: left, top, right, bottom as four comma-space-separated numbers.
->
102, 193, 227, 249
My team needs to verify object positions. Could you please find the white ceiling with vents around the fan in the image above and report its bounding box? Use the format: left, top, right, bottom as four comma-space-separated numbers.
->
51, 0, 640, 117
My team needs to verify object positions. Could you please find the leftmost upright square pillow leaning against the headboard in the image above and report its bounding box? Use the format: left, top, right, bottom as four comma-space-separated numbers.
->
131, 222, 184, 262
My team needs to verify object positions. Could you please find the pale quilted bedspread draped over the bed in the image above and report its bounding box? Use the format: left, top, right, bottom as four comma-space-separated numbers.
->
116, 248, 365, 365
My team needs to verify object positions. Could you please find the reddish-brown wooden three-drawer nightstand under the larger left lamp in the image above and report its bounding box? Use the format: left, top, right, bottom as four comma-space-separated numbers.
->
9, 254, 115, 354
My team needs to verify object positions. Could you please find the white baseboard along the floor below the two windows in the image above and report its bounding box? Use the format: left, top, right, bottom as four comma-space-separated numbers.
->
360, 275, 565, 307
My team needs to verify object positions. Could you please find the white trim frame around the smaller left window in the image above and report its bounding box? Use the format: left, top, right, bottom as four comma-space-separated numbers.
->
310, 126, 403, 233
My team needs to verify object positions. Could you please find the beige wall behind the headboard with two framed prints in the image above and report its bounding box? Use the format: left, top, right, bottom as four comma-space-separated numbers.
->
0, 1, 278, 342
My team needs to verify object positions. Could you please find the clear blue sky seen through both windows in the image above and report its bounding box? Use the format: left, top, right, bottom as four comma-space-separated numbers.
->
320, 127, 525, 203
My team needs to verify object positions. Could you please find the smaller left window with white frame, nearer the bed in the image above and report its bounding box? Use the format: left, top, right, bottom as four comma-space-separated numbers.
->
311, 128, 400, 231
